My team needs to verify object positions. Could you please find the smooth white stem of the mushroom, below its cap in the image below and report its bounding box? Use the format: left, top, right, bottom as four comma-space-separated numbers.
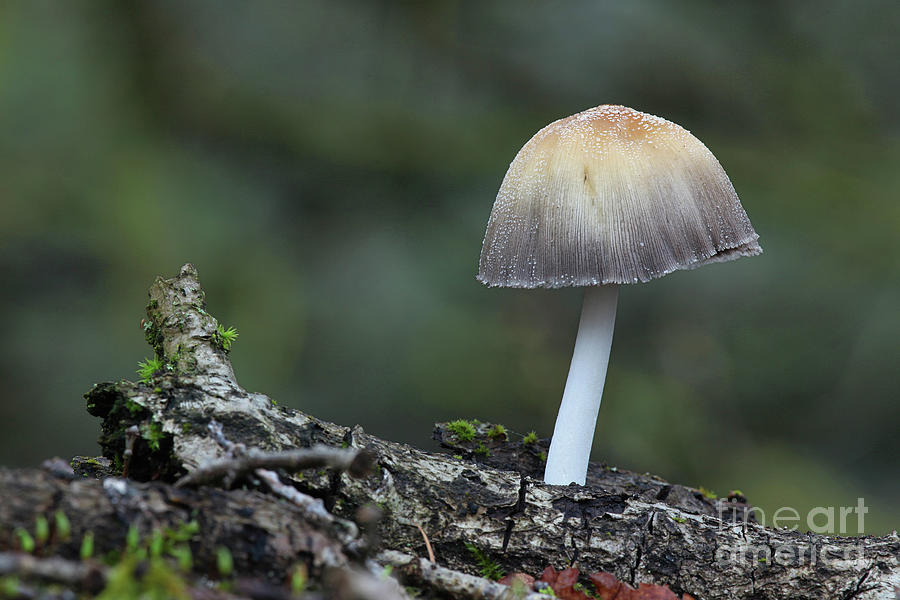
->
544, 285, 619, 485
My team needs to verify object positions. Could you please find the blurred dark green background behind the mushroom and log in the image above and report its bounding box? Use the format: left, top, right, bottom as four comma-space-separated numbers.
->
0, 0, 900, 533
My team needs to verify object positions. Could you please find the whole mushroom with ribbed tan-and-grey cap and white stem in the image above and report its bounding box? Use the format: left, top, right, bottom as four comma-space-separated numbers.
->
478, 104, 762, 485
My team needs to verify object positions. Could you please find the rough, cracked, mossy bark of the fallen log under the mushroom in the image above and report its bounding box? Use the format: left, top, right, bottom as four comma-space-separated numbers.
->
0, 265, 900, 600
